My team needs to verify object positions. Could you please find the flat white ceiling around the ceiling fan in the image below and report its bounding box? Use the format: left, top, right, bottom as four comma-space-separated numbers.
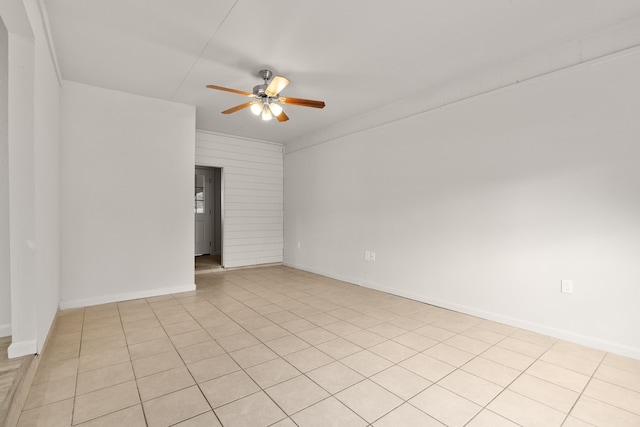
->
45, 0, 640, 143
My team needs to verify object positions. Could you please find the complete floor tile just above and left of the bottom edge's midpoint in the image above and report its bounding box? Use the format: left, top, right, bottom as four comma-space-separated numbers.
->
265, 375, 329, 415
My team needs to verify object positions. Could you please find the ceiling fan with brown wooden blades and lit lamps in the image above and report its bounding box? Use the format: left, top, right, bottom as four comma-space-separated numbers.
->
207, 70, 324, 122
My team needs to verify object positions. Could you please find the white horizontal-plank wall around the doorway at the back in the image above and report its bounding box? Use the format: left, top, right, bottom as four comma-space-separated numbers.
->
196, 131, 283, 267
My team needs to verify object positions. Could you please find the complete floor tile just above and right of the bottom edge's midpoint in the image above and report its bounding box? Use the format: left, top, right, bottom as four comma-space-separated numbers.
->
335, 380, 403, 423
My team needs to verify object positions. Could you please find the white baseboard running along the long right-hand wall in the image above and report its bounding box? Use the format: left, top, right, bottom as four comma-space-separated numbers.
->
285, 263, 640, 359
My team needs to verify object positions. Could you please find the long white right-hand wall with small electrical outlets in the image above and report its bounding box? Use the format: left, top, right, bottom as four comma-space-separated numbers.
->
284, 49, 640, 358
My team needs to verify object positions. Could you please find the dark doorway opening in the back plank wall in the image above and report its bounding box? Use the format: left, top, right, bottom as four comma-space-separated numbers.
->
194, 166, 224, 274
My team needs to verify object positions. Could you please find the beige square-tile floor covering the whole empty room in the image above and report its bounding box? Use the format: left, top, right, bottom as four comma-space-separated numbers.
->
13, 266, 640, 427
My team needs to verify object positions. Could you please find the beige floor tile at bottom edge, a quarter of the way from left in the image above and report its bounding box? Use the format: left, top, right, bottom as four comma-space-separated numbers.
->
143, 386, 211, 427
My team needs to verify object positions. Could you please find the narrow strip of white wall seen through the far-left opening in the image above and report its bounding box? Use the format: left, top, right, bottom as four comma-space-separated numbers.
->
0, 17, 11, 337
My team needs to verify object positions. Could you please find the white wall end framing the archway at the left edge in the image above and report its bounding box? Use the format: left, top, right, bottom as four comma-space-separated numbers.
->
0, 1, 39, 357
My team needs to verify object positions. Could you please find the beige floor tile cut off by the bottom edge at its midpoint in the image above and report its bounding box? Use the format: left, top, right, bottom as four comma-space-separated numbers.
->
292, 397, 367, 427
